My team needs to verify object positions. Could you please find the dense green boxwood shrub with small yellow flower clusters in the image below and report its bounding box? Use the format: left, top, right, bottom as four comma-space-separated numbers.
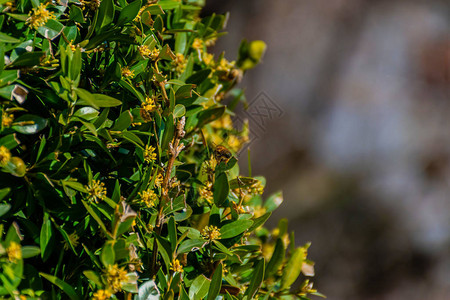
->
0, 0, 322, 299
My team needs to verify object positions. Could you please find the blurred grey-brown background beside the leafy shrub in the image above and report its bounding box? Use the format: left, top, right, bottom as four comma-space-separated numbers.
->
204, 0, 450, 300
